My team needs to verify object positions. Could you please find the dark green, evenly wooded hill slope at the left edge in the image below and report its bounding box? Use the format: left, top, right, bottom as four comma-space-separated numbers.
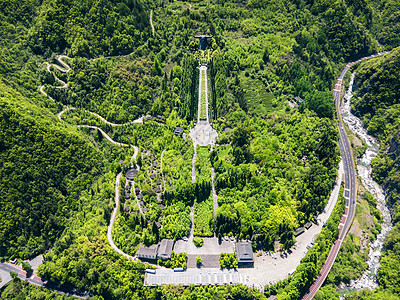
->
0, 82, 102, 258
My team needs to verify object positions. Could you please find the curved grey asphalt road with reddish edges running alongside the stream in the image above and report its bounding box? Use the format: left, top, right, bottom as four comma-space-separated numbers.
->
303, 52, 388, 300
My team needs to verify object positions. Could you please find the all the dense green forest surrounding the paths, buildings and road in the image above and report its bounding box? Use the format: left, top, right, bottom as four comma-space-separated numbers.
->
0, 0, 400, 299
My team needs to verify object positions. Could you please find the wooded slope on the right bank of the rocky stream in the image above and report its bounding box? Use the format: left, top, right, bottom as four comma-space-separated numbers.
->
352, 48, 400, 295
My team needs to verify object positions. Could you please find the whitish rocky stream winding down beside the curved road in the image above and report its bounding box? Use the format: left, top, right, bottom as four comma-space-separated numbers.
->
341, 73, 393, 290
